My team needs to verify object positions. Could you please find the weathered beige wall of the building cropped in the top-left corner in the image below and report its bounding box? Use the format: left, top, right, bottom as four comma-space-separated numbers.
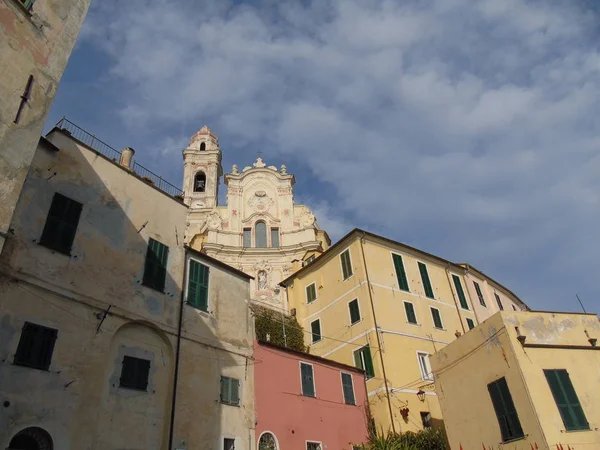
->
0, 0, 90, 255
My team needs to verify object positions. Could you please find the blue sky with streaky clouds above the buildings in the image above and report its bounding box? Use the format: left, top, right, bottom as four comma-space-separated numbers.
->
46, 0, 600, 312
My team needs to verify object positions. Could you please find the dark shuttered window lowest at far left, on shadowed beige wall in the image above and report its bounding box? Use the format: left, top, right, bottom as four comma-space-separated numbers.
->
13, 322, 58, 370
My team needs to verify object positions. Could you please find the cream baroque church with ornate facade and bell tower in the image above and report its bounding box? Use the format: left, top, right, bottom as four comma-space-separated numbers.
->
183, 126, 331, 312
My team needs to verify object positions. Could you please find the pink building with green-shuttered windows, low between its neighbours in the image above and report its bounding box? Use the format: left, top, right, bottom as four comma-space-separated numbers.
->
254, 341, 368, 450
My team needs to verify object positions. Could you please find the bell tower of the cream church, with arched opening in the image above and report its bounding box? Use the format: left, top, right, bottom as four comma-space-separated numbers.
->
183, 125, 223, 209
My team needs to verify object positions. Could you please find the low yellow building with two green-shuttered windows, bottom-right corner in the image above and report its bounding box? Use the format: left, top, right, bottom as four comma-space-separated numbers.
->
432, 311, 600, 450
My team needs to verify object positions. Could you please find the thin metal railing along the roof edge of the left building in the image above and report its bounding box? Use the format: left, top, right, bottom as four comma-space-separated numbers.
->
56, 117, 183, 197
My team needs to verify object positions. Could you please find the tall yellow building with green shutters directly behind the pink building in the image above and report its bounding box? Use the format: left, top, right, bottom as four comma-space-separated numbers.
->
281, 229, 526, 432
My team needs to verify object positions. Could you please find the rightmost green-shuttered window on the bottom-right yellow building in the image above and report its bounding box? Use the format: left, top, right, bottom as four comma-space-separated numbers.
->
544, 369, 590, 431
